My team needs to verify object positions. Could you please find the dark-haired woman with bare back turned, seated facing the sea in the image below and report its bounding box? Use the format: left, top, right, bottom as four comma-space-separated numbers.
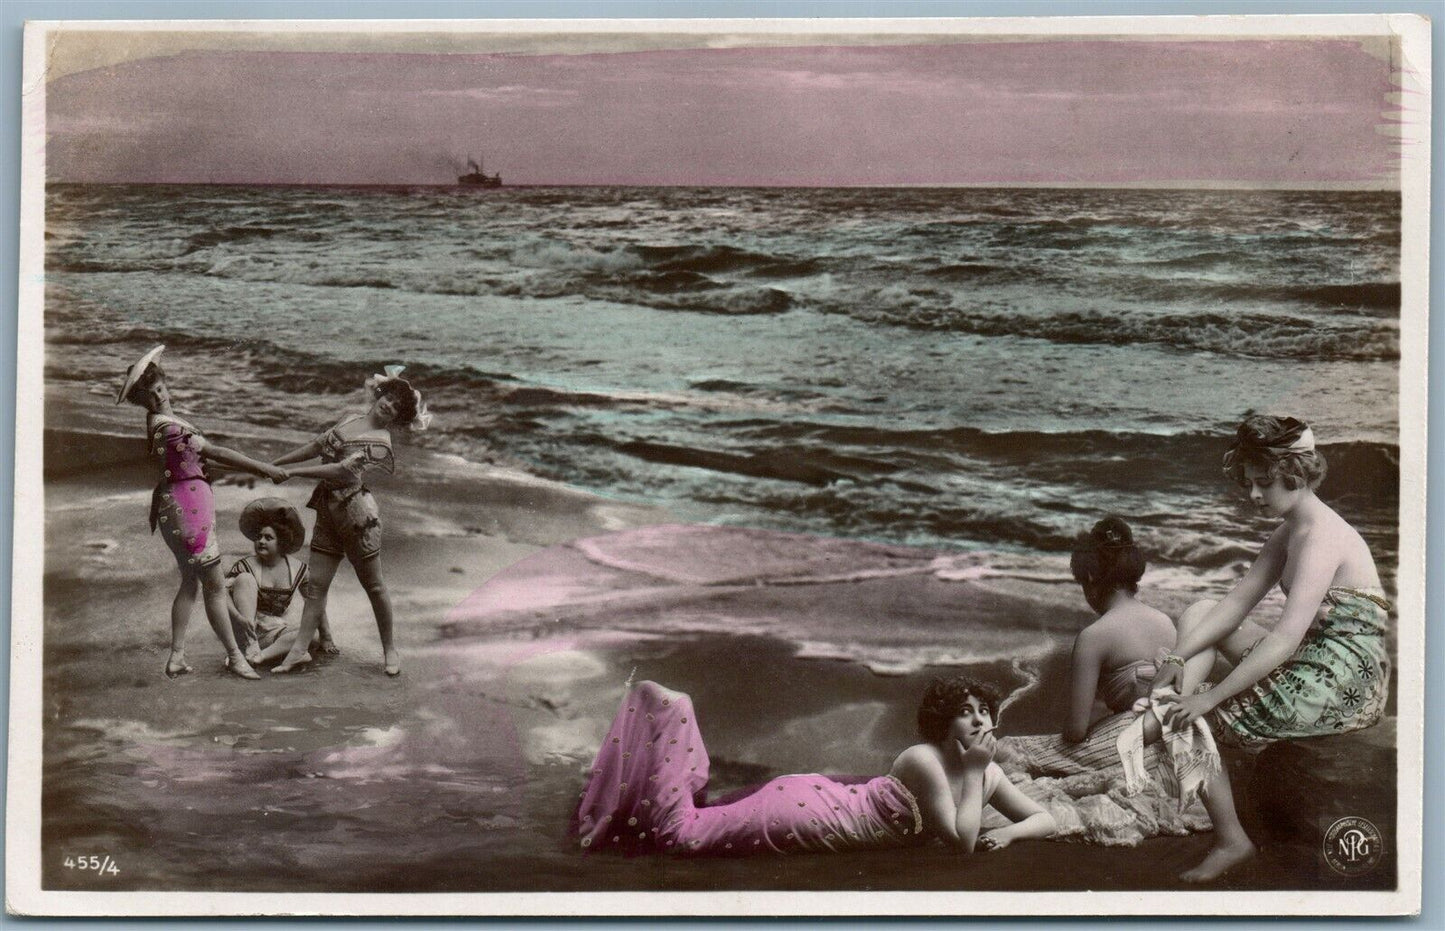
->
998, 516, 1175, 776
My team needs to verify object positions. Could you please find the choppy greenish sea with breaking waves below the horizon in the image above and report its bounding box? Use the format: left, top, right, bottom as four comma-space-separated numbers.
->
45, 184, 1400, 601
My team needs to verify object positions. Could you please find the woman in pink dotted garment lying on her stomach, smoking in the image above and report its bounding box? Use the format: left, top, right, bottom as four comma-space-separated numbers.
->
572, 677, 1056, 856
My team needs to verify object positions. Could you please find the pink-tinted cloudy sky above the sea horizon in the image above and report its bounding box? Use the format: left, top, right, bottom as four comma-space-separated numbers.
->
46, 39, 1399, 185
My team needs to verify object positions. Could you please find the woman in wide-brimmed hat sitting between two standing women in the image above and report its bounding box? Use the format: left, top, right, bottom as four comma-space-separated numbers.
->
225, 497, 338, 666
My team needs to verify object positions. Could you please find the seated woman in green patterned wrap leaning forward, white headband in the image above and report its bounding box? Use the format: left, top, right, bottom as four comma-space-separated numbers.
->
1153, 416, 1390, 879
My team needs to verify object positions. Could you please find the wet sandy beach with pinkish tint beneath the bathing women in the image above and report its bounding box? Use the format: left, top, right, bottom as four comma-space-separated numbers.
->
33, 396, 1393, 911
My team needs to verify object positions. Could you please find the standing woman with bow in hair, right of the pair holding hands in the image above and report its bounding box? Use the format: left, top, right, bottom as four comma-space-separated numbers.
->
273, 366, 431, 675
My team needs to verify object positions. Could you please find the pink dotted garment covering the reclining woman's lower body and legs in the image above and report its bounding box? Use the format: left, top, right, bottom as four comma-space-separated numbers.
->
572, 682, 923, 856
